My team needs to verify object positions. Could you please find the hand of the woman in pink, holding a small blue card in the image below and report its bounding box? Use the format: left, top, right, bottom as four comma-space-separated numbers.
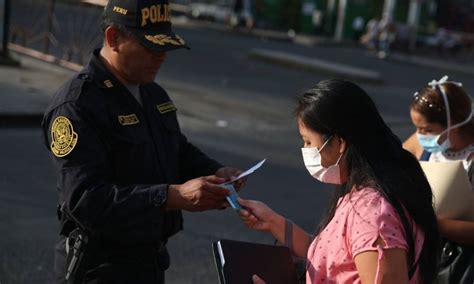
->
238, 198, 285, 233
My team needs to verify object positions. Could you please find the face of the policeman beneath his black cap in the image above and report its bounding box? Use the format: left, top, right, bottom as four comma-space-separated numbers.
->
117, 31, 166, 84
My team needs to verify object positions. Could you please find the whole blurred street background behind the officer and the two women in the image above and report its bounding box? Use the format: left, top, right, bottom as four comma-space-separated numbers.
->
0, 0, 474, 284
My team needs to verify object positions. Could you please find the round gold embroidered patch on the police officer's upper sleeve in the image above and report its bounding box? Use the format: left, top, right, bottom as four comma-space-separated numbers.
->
51, 116, 79, 157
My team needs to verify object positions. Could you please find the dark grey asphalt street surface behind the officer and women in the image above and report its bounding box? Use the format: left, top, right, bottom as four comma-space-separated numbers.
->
0, 15, 474, 284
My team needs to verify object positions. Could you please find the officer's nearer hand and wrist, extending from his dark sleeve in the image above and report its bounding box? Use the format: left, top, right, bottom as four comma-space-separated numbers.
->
166, 176, 230, 211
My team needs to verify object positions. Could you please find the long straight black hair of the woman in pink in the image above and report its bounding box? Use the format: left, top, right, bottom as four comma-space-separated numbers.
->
296, 79, 439, 283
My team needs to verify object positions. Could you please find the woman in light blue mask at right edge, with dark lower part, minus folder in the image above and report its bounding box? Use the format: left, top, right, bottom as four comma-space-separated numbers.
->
403, 76, 474, 284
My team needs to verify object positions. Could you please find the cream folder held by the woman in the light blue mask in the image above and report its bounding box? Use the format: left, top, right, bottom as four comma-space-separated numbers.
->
420, 161, 474, 221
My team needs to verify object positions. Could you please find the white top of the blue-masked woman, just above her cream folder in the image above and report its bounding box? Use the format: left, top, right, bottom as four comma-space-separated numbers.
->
429, 144, 474, 190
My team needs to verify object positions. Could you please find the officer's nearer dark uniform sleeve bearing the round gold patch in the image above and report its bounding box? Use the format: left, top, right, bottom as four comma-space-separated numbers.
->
43, 103, 167, 231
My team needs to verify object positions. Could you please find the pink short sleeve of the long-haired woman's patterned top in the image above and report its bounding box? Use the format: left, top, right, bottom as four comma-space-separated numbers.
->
347, 190, 408, 257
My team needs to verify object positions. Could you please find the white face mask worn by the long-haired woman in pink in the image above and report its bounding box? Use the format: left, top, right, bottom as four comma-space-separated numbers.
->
301, 137, 342, 184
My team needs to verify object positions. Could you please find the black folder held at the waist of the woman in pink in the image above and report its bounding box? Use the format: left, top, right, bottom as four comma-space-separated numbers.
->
212, 240, 298, 284
